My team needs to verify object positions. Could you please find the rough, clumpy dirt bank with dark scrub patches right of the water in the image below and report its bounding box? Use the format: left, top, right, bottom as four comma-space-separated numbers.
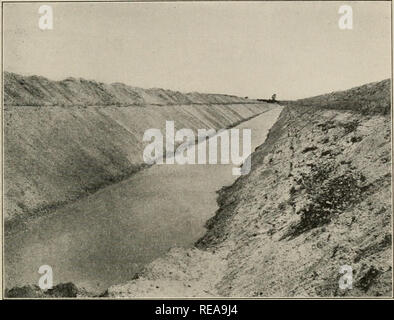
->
108, 81, 392, 297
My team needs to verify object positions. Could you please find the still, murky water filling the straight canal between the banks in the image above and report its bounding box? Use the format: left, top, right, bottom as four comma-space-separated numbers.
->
5, 108, 281, 292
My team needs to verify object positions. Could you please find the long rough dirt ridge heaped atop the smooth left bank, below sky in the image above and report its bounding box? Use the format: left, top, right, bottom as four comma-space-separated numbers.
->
4, 72, 248, 106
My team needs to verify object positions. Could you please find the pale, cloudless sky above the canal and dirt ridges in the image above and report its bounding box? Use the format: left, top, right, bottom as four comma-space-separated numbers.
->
3, 1, 391, 99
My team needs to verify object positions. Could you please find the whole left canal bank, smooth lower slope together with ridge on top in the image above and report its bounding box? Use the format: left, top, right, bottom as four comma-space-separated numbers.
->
4, 73, 271, 232
